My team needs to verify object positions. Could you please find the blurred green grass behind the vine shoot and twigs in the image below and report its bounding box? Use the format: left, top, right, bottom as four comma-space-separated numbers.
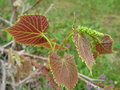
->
0, 0, 120, 90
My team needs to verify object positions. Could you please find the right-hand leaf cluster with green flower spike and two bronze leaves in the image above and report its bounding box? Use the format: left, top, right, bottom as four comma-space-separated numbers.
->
73, 26, 113, 71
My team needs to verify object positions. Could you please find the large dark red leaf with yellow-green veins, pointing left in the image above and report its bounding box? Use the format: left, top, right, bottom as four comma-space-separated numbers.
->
6, 15, 49, 45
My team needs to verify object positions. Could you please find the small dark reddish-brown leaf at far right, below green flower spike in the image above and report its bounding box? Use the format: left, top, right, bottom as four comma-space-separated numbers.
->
96, 35, 113, 54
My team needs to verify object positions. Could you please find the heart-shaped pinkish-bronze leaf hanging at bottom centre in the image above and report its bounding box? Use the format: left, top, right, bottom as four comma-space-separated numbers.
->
50, 52, 78, 90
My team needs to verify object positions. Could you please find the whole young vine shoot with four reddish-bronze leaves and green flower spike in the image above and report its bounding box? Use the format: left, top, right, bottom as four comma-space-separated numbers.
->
6, 15, 113, 90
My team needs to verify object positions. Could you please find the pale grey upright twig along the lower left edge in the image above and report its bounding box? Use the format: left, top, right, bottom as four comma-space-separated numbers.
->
0, 60, 6, 90
